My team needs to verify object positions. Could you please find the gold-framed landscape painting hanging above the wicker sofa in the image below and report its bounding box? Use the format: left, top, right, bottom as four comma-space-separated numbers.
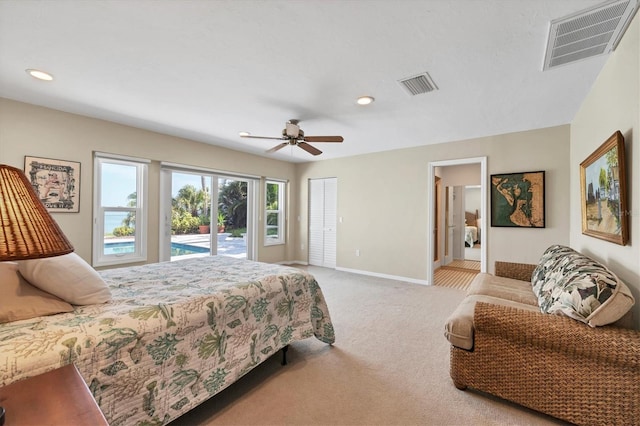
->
580, 131, 629, 246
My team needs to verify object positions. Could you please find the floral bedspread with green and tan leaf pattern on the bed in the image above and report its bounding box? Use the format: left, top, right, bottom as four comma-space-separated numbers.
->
0, 256, 334, 426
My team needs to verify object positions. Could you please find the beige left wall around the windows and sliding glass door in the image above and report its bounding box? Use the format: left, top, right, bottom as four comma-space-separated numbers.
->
0, 98, 297, 262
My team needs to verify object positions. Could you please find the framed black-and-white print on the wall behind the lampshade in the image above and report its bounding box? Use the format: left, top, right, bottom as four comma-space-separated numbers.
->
24, 156, 80, 213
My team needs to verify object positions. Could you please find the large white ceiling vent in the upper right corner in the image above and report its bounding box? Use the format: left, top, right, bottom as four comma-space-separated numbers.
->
543, 0, 638, 70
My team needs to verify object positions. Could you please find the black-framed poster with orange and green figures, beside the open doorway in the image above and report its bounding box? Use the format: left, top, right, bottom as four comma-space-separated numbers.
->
491, 171, 545, 228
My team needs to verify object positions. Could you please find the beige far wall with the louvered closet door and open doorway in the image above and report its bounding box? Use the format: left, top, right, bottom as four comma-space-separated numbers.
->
296, 126, 569, 281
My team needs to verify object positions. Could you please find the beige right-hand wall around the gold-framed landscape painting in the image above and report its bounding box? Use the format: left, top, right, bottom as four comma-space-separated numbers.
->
570, 15, 640, 328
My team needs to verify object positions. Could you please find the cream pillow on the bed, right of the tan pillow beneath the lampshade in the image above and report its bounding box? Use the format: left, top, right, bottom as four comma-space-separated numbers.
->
18, 253, 111, 305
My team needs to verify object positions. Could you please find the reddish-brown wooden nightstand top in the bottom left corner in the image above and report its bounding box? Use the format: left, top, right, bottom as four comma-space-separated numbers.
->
0, 364, 108, 426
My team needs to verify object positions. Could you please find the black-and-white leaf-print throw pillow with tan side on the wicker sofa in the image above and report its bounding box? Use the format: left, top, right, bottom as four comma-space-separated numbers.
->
532, 245, 635, 327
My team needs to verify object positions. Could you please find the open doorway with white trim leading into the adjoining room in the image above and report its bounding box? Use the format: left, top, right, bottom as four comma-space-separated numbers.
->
427, 157, 488, 285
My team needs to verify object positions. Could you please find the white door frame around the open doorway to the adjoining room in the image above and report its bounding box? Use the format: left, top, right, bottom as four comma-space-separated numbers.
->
427, 156, 489, 285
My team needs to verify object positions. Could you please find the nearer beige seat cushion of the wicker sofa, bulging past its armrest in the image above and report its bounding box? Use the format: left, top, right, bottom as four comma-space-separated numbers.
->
444, 294, 540, 350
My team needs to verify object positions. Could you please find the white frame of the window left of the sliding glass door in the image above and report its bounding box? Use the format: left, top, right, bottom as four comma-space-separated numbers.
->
93, 153, 150, 266
